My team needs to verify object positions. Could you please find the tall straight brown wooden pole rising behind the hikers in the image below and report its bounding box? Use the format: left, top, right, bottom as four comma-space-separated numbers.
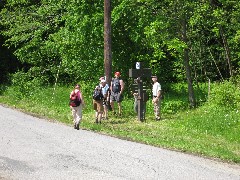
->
104, 0, 112, 84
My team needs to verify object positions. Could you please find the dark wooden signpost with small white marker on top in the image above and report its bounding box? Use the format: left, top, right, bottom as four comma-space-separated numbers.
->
129, 62, 151, 121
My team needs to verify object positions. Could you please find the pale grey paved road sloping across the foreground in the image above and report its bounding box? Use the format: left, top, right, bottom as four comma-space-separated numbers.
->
0, 106, 240, 180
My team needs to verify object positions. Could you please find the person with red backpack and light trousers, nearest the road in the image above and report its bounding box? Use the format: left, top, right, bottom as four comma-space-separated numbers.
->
69, 84, 84, 130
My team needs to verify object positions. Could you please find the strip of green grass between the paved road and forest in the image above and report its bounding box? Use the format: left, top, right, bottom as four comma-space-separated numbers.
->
0, 83, 240, 164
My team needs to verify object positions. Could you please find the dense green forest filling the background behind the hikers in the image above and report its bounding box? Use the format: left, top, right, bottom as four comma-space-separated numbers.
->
0, 0, 240, 106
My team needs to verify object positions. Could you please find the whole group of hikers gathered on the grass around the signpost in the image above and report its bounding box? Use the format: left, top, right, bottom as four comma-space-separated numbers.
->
69, 72, 161, 130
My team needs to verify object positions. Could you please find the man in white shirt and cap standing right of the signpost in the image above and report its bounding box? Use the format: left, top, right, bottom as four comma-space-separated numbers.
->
152, 76, 162, 121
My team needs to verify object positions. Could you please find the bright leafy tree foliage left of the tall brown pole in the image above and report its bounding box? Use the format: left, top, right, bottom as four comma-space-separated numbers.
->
1, 1, 106, 83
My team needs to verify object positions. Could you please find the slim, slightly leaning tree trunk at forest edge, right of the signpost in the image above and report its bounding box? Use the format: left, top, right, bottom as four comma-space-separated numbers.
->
182, 19, 196, 108
